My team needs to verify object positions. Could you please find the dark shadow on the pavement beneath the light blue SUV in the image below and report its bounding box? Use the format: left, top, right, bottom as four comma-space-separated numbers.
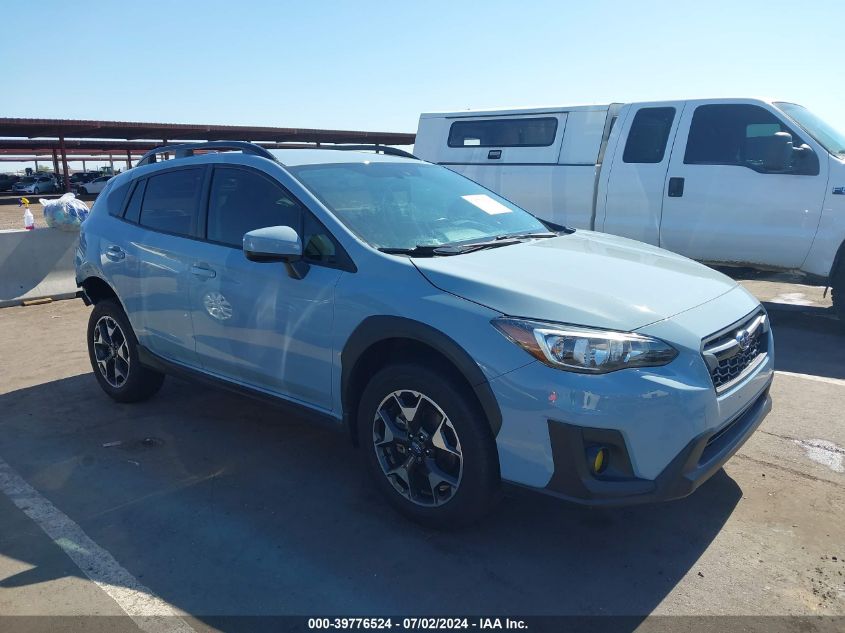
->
0, 374, 741, 628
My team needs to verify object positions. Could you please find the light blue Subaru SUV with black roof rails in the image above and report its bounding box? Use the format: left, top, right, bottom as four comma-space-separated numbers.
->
76, 142, 774, 526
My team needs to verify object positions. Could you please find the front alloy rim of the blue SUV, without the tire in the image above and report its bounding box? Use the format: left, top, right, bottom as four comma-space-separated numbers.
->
373, 389, 463, 507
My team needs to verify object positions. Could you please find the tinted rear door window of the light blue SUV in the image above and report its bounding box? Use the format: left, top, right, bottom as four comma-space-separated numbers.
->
140, 169, 203, 235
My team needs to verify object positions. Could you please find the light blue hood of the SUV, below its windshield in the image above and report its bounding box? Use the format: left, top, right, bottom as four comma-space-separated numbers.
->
413, 231, 736, 330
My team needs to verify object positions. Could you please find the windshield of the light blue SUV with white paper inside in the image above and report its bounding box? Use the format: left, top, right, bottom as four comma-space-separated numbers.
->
289, 162, 548, 249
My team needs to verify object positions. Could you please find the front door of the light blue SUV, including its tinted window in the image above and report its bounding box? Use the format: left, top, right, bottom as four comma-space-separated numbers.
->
190, 166, 343, 409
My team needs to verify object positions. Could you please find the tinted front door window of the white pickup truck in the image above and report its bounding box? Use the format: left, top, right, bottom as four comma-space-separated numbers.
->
684, 104, 819, 174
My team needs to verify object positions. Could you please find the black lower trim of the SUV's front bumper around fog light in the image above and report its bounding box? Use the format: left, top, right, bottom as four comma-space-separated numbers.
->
544, 380, 772, 506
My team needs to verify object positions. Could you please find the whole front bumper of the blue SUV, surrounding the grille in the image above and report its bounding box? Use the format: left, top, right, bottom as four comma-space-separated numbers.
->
490, 288, 774, 505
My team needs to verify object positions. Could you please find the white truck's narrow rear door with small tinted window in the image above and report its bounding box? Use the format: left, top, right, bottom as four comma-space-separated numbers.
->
596, 102, 684, 245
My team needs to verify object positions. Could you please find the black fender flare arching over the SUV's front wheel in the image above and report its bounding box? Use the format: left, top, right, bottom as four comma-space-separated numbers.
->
340, 316, 502, 437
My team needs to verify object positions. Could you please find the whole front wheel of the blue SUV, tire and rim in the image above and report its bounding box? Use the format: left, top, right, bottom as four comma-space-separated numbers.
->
357, 364, 501, 529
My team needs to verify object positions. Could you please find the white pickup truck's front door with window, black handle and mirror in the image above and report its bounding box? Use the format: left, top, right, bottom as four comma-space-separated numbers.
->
660, 101, 828, 268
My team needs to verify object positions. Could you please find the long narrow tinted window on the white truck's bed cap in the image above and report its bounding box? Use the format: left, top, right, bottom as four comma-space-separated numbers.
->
449, 117, 557, 147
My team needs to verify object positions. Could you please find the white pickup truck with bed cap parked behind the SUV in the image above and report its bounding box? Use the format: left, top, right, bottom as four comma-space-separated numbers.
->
414, 99, 845, 321
